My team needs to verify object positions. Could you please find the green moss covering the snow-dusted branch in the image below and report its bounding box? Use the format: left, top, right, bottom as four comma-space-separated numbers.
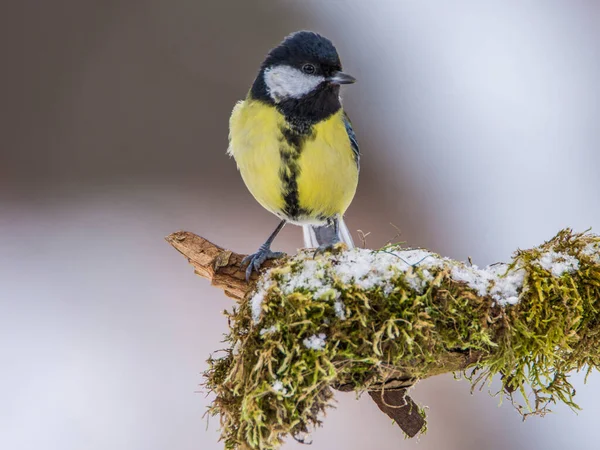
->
205, 230, 600, 449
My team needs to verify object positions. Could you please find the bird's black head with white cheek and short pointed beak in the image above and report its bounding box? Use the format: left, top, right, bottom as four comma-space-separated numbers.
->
253, 31, 356, 104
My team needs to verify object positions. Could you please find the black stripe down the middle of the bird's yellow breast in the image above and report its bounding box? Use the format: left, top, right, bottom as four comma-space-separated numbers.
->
279, 124, 313, 220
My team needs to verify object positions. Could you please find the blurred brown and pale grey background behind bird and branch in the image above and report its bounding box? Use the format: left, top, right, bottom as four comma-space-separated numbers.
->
0, 0, 600, 450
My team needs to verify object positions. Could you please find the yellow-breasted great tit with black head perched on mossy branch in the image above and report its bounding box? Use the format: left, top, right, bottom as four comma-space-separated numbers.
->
227, 30, 360, 280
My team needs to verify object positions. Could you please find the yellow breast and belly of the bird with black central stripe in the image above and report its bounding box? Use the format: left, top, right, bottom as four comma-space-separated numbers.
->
228, 100, 358, 223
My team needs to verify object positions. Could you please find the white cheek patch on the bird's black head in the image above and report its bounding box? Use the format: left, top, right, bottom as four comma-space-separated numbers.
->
264, 66, 325, 102
